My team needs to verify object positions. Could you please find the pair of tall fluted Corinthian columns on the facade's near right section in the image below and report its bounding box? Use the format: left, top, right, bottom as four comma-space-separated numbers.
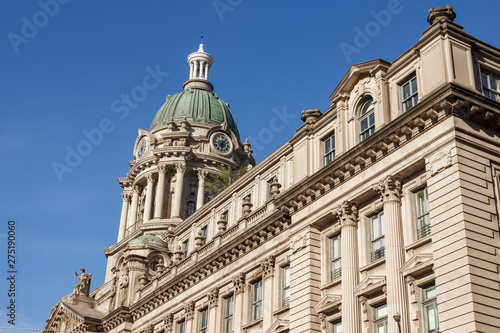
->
335, 176, 409, 333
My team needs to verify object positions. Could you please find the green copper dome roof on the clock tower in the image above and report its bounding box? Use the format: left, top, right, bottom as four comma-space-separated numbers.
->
149, 88, 240, 139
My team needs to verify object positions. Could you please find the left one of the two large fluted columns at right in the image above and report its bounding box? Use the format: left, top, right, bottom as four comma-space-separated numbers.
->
335, 201, 360, 333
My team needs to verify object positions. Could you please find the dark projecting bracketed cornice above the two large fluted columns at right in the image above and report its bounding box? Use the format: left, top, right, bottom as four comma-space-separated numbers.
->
275, 83, 500, 215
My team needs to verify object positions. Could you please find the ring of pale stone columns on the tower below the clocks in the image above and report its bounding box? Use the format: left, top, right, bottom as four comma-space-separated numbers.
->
118, 163, 207, 242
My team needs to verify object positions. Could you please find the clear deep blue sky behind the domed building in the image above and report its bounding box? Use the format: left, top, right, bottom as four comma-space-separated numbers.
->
0, 0, 500, 329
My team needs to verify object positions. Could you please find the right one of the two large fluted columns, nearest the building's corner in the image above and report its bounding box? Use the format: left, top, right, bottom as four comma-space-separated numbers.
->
373, 176, 408, 333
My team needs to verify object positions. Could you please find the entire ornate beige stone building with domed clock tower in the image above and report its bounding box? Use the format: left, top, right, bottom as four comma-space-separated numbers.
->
46, 6, 500, 333
